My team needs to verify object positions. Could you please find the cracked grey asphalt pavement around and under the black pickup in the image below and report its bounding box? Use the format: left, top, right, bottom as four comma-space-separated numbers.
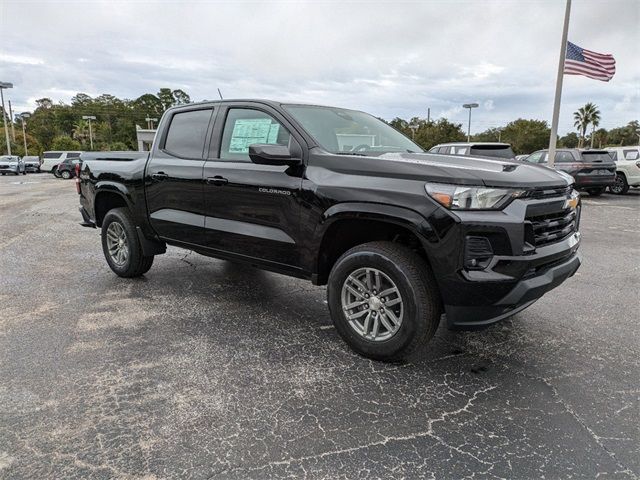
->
0, 174, 640, 479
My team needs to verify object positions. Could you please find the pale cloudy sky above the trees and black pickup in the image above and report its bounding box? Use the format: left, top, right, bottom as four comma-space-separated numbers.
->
0, 0, 640, 133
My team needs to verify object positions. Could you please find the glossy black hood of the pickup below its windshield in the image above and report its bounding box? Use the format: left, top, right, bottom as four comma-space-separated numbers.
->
327, 153, 573, 188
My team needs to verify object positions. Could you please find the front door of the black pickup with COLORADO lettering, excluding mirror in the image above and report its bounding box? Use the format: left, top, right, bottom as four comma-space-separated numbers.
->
204, 103, 304, 270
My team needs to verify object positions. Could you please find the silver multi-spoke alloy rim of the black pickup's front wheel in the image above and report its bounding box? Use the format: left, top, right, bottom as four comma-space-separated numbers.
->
341, 268, 404, 342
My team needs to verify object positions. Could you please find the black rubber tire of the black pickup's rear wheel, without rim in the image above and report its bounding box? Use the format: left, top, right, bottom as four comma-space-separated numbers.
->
102, 208, 154, 278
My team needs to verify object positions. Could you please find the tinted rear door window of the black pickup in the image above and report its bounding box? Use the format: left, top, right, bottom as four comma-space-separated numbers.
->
164, 108, 213, 160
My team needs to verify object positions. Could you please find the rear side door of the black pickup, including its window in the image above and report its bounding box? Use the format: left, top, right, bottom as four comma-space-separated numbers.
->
145, 106, 214, 245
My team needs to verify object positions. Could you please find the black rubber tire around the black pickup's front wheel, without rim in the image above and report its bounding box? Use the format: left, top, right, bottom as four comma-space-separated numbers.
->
327, 242, 442, 362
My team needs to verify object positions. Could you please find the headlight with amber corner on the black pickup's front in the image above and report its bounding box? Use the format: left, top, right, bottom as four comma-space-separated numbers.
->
425, 183, 524, 210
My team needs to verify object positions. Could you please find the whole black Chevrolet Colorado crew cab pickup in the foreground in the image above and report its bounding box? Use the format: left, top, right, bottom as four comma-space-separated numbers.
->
76, 100, 580, 361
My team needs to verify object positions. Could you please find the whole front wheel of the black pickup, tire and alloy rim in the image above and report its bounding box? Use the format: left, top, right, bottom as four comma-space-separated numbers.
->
327, 242, 442, 362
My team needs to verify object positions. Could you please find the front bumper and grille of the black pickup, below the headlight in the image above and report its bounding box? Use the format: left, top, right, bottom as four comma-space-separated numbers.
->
425, 193, 582, 330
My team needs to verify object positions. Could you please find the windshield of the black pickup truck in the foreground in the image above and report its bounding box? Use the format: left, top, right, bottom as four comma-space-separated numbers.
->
285, 105, 423, 155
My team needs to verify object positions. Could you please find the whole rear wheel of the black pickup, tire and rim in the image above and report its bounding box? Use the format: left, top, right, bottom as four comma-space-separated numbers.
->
102, 208, 154, 278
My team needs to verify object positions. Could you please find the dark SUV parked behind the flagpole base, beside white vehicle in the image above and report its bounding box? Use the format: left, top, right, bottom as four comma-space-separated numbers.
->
524, 148, 616, 197
